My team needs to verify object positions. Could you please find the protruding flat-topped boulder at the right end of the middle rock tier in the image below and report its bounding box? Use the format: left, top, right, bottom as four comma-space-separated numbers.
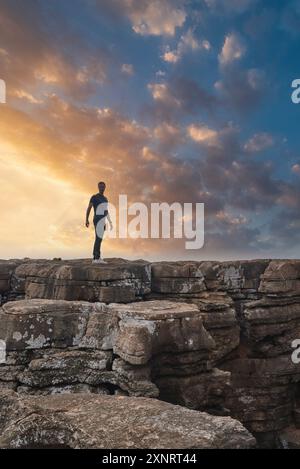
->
108, 300, 215, 365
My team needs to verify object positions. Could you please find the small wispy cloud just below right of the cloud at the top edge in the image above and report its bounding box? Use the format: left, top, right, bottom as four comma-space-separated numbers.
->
162, 29, 211, 63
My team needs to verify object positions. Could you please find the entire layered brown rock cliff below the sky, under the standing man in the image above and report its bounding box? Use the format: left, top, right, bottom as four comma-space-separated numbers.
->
0, 259, 300, 447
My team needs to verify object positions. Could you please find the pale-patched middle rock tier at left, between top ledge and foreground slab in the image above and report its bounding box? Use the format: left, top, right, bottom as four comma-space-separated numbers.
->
0, 299, 230, 413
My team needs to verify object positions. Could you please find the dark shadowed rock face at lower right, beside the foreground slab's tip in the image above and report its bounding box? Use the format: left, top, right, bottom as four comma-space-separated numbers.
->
220, 357, 300, 434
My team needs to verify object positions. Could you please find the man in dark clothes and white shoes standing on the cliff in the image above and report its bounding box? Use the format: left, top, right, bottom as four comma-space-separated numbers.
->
85, 181, 113, 264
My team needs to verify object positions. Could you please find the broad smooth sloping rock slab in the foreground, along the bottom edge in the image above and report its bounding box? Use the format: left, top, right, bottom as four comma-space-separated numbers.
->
0, 391, 255, 449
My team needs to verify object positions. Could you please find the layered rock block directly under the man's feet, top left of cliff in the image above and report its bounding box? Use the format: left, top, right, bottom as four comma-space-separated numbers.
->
0, 259, 151, 303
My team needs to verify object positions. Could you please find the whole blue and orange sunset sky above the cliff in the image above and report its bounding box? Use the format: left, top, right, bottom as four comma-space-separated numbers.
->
0, 0, 300, 260
